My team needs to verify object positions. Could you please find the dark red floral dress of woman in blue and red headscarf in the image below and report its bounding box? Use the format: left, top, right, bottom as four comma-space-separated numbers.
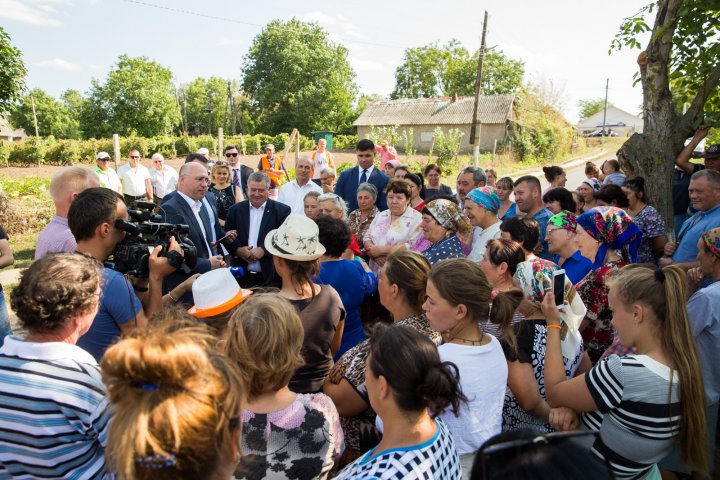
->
575, 261, 626, 365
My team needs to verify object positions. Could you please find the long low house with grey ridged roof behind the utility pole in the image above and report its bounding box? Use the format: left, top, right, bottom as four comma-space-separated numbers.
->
353, 94, 515, 152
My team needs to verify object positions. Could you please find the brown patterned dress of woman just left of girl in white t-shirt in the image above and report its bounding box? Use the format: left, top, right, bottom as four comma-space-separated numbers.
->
328, 314, 442, 466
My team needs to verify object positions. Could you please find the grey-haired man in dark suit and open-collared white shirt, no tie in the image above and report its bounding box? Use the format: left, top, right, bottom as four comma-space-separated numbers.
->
225, 172, 290, 288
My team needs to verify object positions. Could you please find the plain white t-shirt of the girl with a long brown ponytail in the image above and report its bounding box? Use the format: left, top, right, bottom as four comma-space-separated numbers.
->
438, 334, 508, 455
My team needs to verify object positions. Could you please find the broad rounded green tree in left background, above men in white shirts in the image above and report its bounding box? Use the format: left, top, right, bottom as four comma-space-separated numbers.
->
81, 55, 180, 137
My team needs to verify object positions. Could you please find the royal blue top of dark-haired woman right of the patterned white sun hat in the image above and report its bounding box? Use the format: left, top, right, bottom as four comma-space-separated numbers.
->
316, 260, 377, 361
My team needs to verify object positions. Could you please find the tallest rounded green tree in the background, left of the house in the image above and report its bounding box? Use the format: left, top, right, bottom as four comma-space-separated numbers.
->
242, 18, 357, 134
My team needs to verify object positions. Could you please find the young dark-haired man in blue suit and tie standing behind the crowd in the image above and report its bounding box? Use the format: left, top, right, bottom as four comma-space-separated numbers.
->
335, 139, 390, 212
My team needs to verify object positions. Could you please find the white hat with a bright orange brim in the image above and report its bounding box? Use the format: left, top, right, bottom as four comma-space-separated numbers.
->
188, 268, 252, 318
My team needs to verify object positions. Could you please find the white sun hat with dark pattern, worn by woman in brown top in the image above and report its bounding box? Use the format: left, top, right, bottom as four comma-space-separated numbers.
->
265, 214, 325, 262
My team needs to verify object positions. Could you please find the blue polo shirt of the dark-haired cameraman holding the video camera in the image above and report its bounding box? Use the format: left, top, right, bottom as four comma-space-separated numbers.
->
77, 268, 142, 362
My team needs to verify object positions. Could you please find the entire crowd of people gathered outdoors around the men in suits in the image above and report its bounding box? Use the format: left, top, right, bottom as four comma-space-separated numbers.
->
0, 128, 720, 480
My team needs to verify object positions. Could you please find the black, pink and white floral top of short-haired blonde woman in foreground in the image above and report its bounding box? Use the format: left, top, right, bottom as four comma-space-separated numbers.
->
235, 393, 343, 480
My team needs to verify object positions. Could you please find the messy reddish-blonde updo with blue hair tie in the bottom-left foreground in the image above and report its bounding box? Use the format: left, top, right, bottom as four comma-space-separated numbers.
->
101, 323, 245, 480
